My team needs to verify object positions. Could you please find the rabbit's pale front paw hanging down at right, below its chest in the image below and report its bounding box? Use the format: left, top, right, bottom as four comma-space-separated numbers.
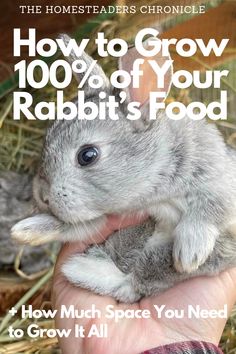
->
173, 224, 218, 273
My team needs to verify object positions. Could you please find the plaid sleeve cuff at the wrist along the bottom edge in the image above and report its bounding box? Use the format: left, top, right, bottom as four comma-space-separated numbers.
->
142, 341, 223, 354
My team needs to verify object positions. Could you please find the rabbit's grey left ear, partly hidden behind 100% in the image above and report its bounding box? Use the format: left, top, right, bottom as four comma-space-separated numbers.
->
58, 34, 109, 95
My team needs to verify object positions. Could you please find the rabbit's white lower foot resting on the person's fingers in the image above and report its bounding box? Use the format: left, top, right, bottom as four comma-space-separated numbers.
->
62, 252, 140, 302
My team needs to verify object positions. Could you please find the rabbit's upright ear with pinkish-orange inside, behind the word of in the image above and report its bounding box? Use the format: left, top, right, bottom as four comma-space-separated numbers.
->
119, 37, 173, 127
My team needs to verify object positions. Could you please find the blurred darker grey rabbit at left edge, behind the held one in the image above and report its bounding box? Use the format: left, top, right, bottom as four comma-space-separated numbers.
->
0, 171, 56, 275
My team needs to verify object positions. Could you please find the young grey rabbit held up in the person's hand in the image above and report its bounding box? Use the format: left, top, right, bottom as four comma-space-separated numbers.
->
12, 35, 236, 303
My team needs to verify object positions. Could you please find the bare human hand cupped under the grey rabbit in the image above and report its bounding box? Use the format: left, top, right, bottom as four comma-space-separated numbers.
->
52, 216, 236, 354
